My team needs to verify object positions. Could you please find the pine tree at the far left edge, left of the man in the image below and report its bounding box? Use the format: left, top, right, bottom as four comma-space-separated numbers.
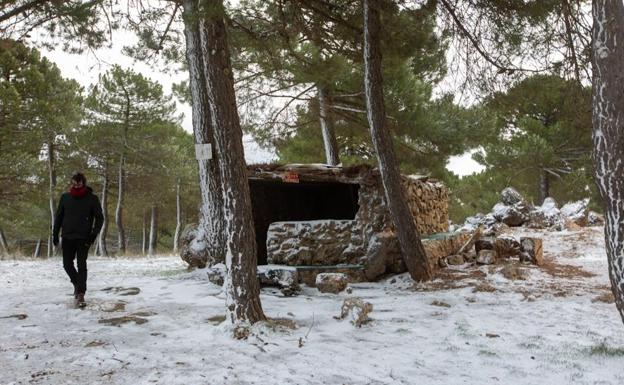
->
0, 40, 82, 257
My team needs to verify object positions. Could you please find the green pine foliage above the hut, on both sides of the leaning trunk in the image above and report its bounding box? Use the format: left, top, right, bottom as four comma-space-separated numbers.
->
233, 1, 489, 176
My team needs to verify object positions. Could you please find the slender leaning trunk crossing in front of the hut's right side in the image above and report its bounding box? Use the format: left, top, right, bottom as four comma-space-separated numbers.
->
364, 0, 431, 281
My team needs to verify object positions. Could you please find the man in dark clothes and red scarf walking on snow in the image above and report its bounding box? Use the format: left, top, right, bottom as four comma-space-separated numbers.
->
52, 173, 104, 306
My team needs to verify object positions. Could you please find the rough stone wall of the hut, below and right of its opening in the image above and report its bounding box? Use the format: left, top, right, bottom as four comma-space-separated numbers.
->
267, 176, 458, 279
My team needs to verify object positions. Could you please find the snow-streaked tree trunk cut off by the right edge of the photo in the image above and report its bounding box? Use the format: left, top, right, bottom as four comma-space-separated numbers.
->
592, 0, 624, 321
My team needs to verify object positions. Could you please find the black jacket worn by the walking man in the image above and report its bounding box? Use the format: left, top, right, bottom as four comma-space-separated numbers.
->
52, 187, 104, 243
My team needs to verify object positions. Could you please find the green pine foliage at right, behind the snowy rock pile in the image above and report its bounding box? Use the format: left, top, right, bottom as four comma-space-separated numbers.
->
445, 75, 601, 221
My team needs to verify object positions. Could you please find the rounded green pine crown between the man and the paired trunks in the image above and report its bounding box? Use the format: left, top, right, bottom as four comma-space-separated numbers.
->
78, 66, 198, 252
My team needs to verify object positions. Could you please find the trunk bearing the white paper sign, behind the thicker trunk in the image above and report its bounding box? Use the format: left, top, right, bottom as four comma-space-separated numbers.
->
183, 0, 226, 262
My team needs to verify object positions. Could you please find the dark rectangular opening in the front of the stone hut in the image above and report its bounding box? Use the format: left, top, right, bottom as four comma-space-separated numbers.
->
249, 179, 360, 265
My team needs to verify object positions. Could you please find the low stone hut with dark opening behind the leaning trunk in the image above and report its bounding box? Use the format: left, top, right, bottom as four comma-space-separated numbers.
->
248, 164, 466, 283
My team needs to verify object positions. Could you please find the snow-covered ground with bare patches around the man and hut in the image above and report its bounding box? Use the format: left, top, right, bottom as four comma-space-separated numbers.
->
0, 228, 624, 385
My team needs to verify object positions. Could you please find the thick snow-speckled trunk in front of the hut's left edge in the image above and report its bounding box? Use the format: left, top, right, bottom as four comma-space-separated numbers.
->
200, 0, 266, 324
